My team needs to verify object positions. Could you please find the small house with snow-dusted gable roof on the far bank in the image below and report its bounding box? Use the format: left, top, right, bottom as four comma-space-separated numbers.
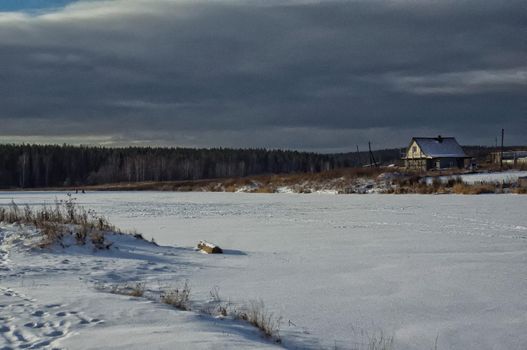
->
403, 135, 470, 171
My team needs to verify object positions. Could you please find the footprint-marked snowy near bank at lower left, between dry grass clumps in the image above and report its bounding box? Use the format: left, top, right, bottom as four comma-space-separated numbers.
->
0, 225, 288, 349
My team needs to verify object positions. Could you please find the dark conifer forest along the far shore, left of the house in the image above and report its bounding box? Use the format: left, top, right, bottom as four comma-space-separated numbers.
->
0, 145, 364, 189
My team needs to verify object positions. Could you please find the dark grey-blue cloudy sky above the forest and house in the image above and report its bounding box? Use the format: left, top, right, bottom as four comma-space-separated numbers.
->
0, 0, 527, 152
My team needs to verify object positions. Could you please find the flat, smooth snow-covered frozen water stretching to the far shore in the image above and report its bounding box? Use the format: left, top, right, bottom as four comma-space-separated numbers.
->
0, 192, 527, 350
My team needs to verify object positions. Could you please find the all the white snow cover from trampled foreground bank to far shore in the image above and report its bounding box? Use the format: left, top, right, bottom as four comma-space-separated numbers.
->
0, 192, 527, 350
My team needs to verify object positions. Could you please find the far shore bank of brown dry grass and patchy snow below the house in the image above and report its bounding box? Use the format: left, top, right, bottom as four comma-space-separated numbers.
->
75, 167, 527, 194
